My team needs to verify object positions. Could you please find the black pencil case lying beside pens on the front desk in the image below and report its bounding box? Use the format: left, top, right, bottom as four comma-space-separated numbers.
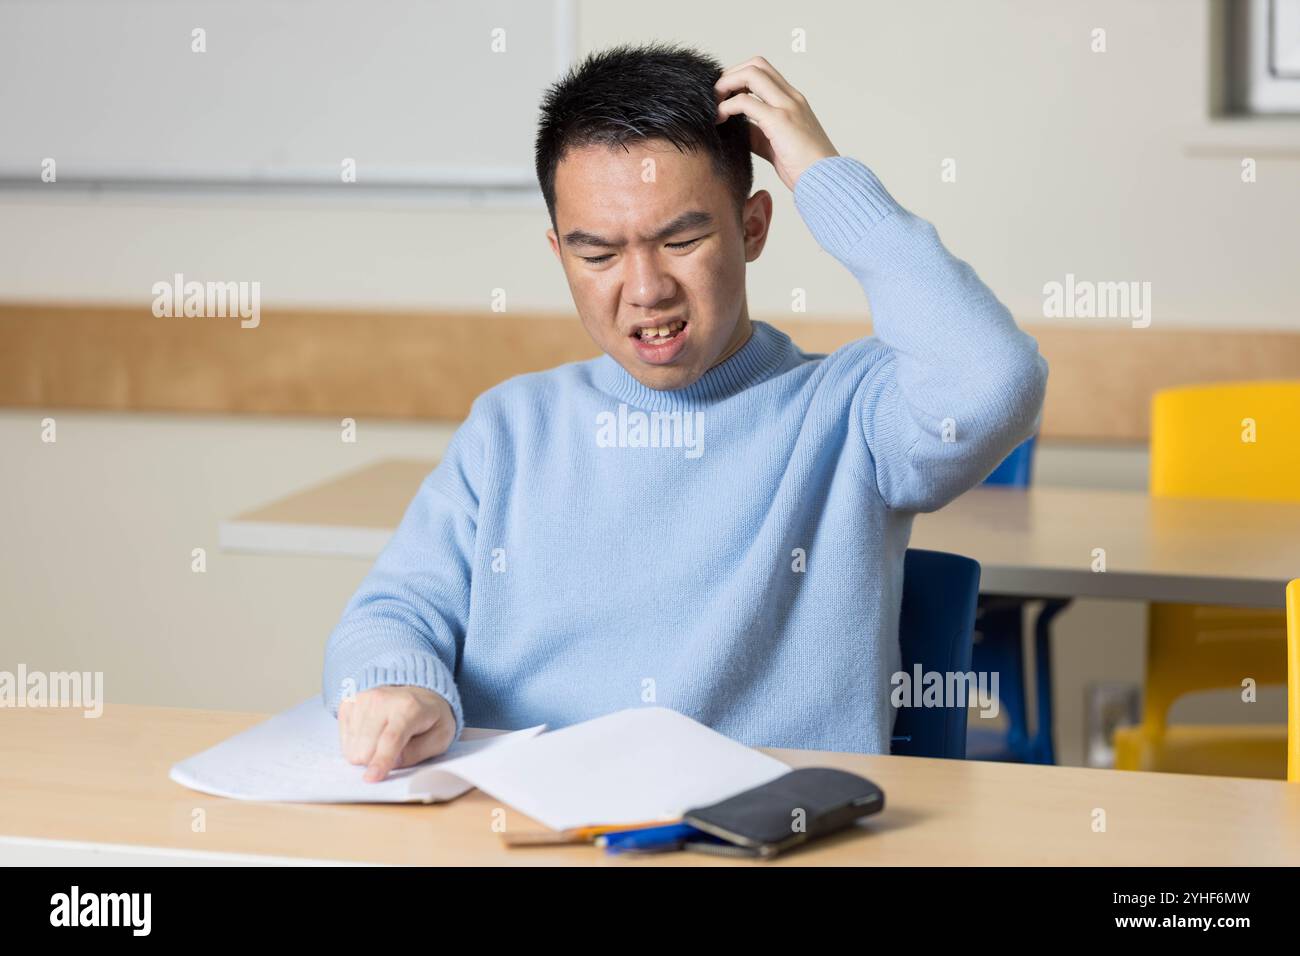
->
681, 767, 885, 858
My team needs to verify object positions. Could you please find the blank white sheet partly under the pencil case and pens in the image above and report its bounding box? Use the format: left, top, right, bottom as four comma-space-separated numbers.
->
431, 708, 790, 830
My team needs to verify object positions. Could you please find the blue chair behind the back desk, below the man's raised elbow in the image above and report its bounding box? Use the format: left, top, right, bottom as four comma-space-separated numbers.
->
966, 437, 1070, 763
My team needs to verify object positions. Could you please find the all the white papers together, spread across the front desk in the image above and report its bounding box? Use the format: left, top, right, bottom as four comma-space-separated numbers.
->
170, 697, 789, 830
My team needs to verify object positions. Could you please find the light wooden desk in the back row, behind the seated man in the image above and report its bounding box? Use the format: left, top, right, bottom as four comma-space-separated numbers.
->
221, 460, 1300, 607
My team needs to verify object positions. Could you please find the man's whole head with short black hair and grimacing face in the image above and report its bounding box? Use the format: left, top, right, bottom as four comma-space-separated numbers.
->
537, 44, 772, 389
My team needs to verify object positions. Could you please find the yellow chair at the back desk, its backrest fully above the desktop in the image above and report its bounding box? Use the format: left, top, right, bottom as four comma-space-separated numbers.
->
1114, 381, 1300, 779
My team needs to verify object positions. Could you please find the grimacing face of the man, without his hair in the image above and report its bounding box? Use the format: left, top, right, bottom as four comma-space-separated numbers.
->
546, 140, 772, 389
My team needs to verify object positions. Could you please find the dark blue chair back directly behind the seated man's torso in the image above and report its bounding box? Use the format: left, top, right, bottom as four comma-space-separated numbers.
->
889, 548, 979, 760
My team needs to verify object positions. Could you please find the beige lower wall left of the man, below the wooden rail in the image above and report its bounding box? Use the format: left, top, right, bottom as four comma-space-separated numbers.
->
0, 411, 452, 710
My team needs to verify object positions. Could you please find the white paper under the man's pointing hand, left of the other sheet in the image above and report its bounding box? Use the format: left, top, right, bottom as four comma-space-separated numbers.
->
169, 696, 546, 804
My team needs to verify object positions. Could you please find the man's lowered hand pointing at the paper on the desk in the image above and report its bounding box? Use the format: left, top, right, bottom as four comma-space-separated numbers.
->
338, 685, 456, 783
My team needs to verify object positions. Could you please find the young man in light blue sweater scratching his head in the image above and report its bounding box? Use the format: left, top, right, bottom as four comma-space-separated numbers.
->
322, 44, 1047, 779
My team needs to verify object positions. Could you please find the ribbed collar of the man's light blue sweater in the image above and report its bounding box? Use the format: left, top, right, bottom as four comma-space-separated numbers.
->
592, 320, 794, 411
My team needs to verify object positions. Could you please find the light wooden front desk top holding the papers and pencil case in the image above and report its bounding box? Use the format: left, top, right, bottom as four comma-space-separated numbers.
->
0, 705, 1300, 866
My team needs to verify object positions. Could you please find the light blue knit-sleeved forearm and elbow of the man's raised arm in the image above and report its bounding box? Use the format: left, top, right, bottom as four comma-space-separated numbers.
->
796, 156, 1047, 510
